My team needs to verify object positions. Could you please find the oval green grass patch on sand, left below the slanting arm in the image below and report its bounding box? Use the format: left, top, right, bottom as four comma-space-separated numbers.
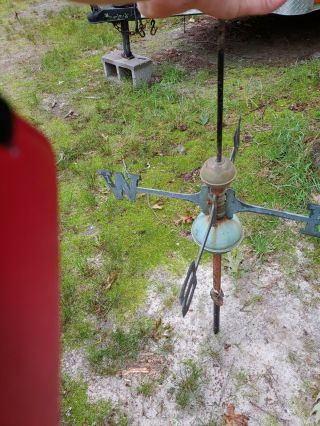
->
88, 318, 153, 375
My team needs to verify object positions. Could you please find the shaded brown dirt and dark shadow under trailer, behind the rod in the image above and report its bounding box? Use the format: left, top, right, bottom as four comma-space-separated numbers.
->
152, 12, 320, 70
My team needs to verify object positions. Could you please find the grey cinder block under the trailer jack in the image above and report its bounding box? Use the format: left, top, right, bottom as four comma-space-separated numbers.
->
102, 50, 153, 87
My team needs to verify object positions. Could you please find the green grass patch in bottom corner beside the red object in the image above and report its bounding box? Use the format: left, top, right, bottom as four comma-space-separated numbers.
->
61, 377, 128, 426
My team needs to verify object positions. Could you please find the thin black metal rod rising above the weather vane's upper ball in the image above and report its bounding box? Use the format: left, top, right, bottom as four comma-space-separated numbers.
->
217, 21, 226, 163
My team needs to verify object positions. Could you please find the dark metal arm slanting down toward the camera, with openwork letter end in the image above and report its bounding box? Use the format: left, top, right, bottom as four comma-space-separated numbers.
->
179, 202, 217, 316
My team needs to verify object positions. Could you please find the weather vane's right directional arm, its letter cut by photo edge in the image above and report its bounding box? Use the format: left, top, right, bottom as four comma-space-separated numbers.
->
226, 189, 320, 238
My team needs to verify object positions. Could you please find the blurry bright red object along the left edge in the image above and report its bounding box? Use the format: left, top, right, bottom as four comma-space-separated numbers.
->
0, 116, 59, 426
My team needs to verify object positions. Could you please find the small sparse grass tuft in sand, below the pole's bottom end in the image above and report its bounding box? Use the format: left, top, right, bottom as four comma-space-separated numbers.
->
175, 359, 205, 409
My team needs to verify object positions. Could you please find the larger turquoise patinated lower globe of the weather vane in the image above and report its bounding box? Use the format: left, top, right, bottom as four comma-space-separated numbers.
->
191, 213, 243, 253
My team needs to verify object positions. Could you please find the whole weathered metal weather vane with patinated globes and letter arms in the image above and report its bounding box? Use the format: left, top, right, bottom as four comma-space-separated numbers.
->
98, 21, 320, 334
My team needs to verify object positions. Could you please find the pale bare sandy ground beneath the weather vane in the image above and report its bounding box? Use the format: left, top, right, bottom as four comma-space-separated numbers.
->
63, 240, 320, 426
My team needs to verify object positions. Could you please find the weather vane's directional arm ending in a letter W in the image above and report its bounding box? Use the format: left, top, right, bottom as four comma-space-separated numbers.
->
98, 170, 209, 212
